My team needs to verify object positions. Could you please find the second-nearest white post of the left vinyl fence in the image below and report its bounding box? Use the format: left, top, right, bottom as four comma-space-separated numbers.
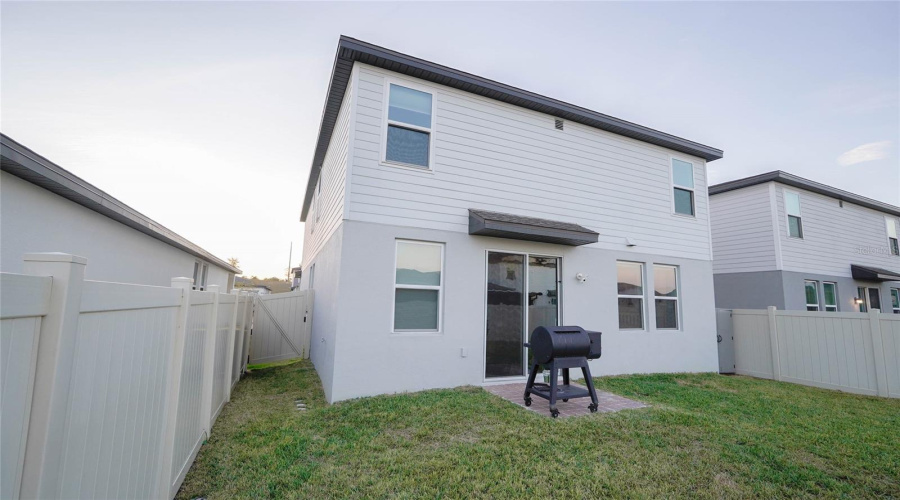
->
153, 278, 194, 498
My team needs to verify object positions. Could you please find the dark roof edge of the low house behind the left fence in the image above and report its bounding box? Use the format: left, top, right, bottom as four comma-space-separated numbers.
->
0, 133, 241, 274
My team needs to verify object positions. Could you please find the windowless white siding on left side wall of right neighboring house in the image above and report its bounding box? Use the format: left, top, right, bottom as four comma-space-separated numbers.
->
709, 184, 777, 273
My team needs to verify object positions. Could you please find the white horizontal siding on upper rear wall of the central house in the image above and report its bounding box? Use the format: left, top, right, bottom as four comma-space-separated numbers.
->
345, 64, 710, 260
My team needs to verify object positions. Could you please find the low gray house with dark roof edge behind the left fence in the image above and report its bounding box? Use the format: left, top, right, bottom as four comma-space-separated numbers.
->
0, 134, 240, 292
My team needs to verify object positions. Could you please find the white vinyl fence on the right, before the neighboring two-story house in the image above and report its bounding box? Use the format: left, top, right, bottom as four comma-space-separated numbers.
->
731, 307, 900, 398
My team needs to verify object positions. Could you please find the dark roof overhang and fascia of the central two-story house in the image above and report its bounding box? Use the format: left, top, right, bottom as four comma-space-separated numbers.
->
300, 36, 723, 221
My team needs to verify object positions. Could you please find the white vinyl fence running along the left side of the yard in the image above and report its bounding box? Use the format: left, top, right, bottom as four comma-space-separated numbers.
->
0, 253, 253, 499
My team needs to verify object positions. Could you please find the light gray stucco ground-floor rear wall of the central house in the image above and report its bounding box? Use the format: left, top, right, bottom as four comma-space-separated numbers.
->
324, 221, 718, 401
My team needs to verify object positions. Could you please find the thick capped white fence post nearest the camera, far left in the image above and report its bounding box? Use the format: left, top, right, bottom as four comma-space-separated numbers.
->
20, 253, 87, 498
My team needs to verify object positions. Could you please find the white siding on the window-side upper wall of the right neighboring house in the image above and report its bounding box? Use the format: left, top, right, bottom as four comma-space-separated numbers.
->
775, 184, 900, 277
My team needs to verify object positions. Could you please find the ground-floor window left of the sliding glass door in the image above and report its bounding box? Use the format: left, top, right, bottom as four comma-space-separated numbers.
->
394, 240, 444, 332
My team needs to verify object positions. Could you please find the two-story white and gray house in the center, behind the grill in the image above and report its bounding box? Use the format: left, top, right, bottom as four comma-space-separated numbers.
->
301, 37, 722, 401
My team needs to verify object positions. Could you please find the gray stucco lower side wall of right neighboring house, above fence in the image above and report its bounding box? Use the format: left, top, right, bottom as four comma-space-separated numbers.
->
713, 271, 784, 309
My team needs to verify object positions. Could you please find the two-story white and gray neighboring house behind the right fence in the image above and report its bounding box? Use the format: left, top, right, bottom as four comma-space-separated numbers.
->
709, 171, 900, 314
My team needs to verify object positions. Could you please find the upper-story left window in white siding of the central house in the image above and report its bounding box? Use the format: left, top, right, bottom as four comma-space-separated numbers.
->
384, 83, 434, 169
